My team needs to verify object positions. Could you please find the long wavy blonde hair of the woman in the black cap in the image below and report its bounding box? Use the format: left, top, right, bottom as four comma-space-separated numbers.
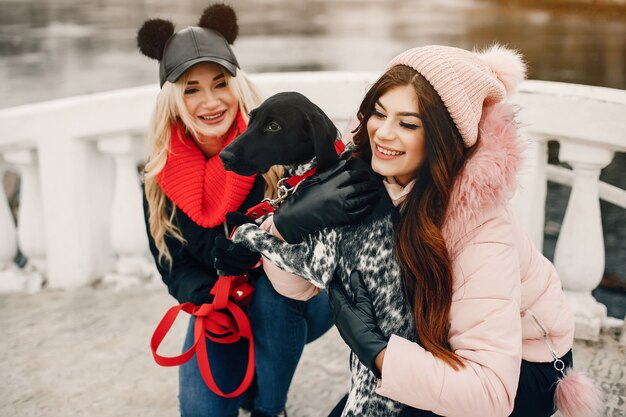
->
144, 70, 283, 268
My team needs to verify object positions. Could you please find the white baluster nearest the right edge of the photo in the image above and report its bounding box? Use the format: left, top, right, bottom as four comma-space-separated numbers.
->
554, 141, 613, 340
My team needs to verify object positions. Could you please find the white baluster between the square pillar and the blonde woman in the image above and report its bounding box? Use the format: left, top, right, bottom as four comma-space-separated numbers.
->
98, 134, 154, 287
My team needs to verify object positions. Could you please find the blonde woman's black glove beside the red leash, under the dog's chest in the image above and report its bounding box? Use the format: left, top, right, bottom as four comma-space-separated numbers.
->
211, 212, 261, 275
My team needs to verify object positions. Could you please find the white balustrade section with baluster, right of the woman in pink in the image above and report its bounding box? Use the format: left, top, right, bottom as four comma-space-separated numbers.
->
515, 81, 626, 340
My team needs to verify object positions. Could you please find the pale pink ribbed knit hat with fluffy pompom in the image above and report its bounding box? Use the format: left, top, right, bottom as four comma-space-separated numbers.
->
387, 45, 526, 147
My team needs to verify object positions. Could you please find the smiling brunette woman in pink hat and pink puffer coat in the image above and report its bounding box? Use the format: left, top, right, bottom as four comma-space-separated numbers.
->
330, 46, 597, 417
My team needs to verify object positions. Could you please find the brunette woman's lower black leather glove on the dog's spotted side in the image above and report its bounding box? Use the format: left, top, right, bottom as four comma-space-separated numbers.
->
328, 269, 389, 378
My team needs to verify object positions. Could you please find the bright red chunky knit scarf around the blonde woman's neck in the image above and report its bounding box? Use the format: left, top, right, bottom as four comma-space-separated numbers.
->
157, 112, 255, 227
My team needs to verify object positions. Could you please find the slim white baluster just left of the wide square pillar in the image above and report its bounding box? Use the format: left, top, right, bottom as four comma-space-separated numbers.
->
4, 150, 46, 291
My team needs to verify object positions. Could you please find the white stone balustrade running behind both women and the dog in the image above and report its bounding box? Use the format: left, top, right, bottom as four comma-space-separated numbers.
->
0, 72, 626, 339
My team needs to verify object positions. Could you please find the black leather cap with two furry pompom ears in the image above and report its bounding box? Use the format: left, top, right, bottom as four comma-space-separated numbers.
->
137, 4, 239, 87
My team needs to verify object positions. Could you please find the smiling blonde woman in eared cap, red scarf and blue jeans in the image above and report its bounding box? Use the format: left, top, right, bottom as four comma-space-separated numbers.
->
137, 5, 372, 417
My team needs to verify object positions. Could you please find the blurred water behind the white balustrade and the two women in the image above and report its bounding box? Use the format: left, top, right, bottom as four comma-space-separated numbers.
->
0, 0, 626, 316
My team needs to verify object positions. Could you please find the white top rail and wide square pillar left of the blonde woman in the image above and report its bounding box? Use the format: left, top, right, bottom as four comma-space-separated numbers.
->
0, 85, 158, 288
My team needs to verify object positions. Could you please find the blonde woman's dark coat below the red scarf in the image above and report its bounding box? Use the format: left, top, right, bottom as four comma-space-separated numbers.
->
143, 175, 265, 305
